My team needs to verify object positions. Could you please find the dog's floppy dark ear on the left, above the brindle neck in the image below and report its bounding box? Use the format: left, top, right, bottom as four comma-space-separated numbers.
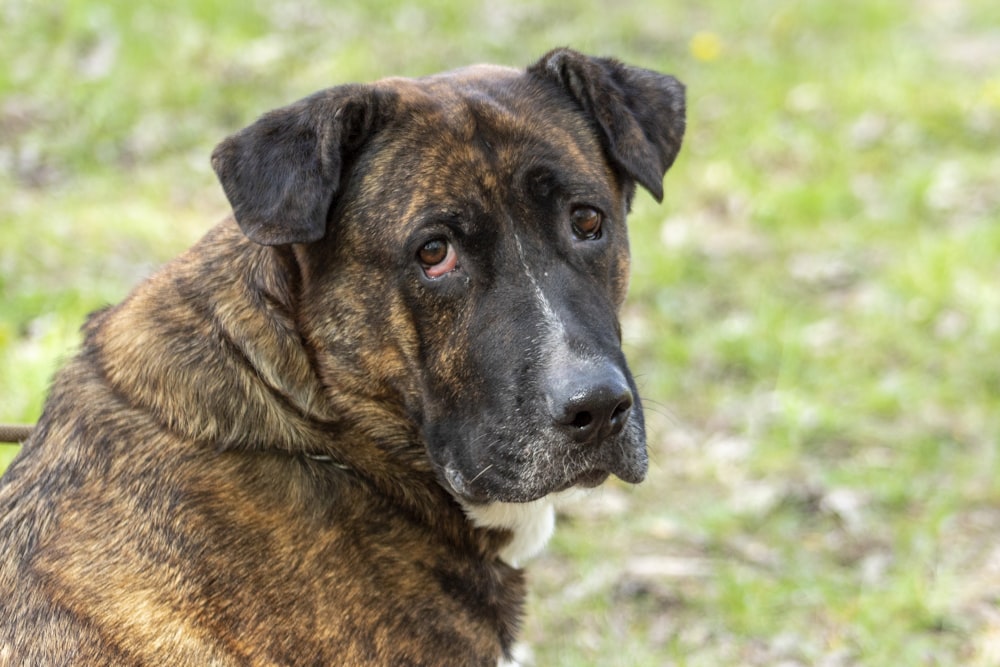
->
212, 86, 377, 245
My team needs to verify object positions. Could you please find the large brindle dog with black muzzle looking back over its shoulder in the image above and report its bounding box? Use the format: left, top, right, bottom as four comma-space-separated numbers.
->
0, 49, 685, 666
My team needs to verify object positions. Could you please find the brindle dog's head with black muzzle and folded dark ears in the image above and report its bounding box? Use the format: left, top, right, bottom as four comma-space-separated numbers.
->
207, 50, 684, 504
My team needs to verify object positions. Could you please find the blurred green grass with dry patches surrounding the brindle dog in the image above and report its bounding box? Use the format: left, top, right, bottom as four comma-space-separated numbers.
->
0, 0, 1000, 667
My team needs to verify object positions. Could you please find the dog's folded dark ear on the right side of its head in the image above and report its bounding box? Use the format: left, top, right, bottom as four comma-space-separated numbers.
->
528, 49, 684, 201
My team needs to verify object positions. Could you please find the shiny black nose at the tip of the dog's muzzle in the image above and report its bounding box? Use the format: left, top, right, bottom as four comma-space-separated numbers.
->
547, 365, 633, 442
